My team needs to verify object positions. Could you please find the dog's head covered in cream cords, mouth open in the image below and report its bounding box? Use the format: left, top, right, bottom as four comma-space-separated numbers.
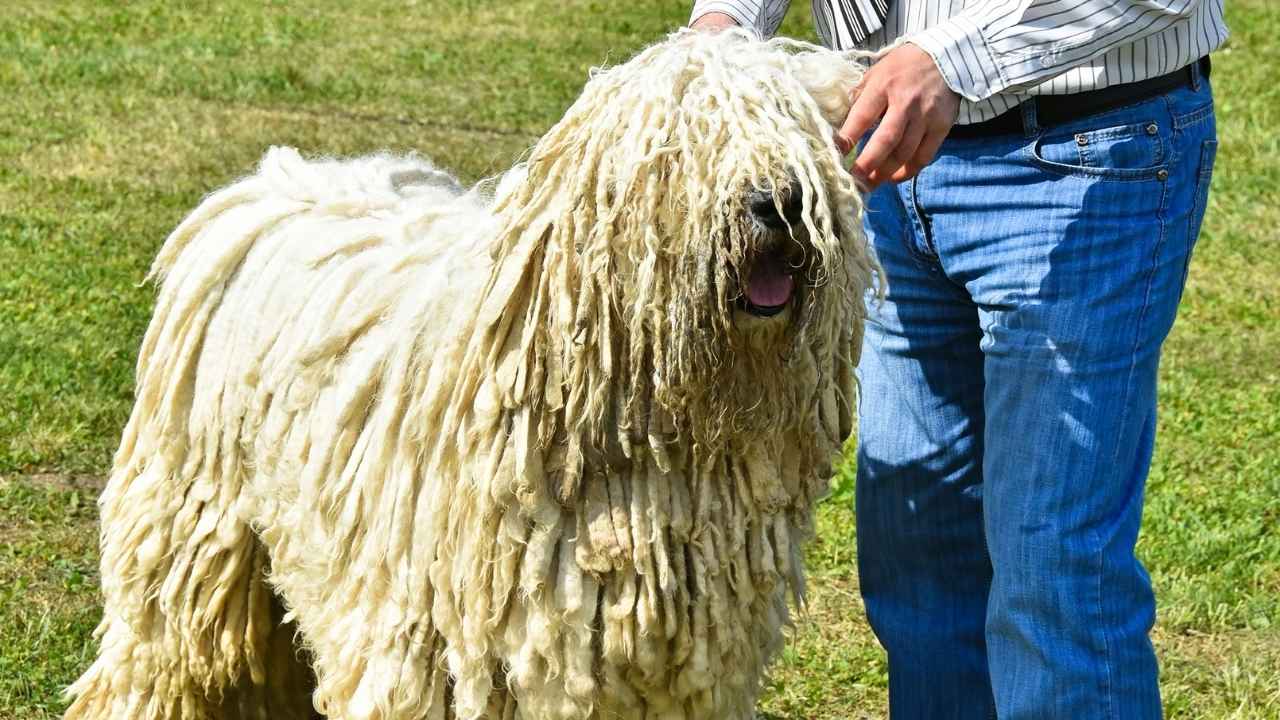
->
483, 31, 873, 437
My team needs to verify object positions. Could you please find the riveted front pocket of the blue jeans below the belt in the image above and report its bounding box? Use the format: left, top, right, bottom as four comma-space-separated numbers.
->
1029, 118, 1169, 181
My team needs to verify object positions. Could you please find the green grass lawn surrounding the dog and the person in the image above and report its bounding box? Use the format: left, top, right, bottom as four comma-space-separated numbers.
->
0, 0, 1280, 720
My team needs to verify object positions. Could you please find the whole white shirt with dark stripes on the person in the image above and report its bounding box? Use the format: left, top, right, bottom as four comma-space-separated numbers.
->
691, 0, 1226, 124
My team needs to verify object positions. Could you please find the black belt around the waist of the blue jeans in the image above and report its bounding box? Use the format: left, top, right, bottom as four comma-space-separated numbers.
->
947, 55, 1210, 138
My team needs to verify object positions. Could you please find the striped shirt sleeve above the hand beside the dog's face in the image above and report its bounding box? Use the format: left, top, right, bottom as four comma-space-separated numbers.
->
905, 0, 1201, 102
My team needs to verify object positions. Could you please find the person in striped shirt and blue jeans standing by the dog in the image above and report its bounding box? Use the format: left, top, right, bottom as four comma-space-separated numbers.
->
690, 0, 1226, 720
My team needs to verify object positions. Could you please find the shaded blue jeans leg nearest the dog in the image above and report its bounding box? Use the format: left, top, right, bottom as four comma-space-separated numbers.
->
856, 179, 995, 720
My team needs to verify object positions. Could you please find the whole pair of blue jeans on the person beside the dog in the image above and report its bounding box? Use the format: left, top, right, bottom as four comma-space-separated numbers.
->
856, 70, 1217, 720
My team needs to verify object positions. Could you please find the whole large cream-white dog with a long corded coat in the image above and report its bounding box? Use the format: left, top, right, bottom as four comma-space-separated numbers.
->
67, 32, 874, 720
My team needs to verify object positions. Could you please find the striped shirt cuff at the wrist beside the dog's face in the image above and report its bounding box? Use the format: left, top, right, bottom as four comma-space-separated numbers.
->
906, 15, 1009, 102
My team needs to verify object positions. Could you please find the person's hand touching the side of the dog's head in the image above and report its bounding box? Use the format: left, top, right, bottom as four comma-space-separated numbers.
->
836, 44, 960, 190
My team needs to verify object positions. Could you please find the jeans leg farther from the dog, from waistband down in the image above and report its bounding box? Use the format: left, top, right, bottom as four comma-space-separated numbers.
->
926, 81, 1213, 720
